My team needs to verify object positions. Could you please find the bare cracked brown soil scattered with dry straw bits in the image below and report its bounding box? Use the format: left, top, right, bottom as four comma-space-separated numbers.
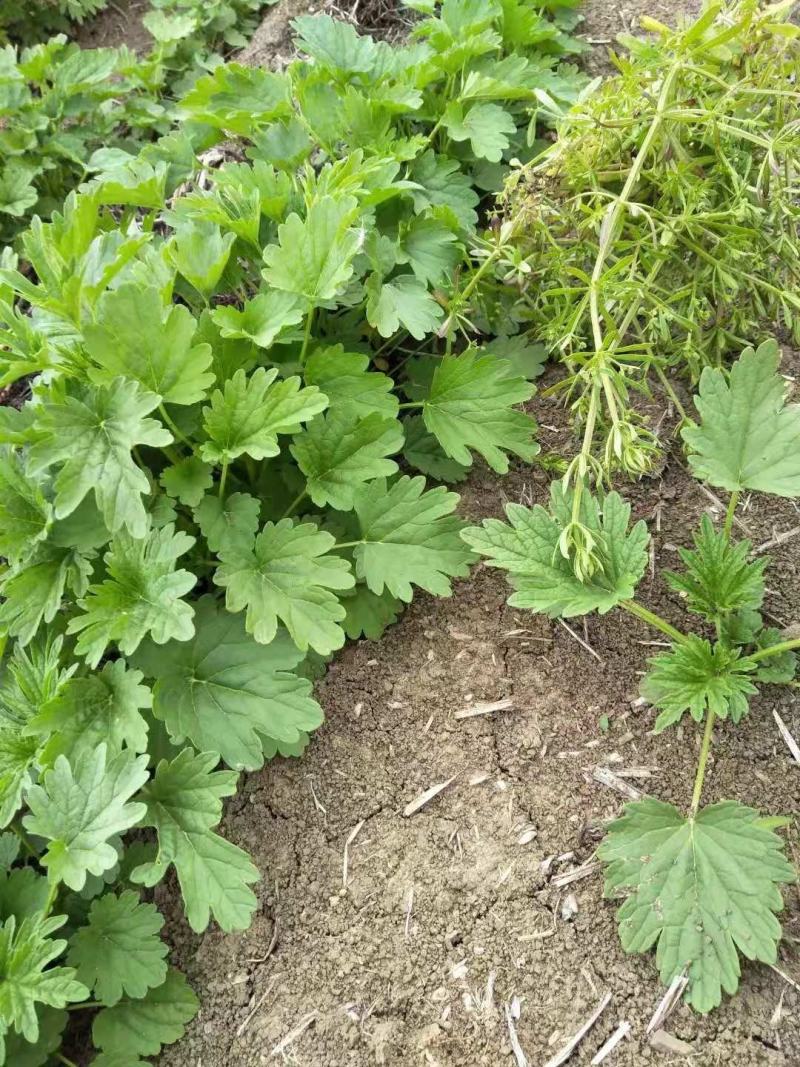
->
70, 0, 800, 1067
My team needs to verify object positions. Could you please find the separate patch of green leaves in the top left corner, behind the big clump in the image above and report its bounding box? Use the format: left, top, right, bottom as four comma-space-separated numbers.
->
0, 0, 279, 243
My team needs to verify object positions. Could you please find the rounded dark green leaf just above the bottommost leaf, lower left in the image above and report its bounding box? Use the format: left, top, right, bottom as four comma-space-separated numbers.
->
67, 890, 169, 1004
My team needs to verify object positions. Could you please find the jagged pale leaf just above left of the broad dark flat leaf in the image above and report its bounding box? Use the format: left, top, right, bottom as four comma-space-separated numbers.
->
67, 524, 197, 667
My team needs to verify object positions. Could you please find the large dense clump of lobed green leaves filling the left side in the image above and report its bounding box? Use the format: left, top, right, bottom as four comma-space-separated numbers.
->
0, 0, 581, 1067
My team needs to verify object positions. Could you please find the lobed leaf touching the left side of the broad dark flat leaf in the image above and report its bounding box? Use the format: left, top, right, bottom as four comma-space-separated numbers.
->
28, 659, 153, 766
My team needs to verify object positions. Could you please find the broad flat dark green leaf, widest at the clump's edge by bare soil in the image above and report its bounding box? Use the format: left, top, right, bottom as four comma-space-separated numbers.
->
135, 598, 322, 770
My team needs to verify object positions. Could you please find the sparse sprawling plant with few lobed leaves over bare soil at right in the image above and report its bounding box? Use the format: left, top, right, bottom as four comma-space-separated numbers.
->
463, 341, 800, 1012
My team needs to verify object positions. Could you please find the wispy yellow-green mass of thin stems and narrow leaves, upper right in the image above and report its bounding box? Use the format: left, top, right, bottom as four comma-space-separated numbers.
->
499, 0, 800, 476
